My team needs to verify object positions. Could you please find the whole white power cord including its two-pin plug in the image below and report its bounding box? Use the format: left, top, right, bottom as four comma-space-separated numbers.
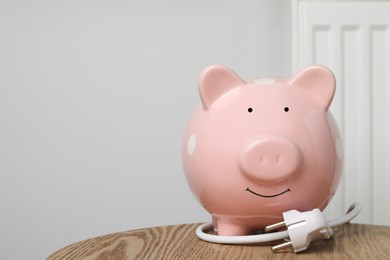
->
196, 202, 361, 253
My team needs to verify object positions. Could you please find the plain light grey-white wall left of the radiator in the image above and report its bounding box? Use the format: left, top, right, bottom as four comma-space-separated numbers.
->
0, 0, 291, 259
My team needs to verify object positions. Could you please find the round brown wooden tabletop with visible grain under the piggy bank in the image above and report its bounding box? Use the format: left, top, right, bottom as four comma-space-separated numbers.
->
47, 224, 390, 260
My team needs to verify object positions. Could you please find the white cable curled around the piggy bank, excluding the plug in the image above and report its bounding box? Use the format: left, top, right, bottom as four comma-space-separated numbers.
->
196, 202, 361, 244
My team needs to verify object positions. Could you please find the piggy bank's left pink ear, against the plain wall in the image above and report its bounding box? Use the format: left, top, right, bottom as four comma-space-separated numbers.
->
199, 65, 245, 110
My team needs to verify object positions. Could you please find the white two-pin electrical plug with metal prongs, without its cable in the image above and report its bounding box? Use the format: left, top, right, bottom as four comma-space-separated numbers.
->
265, 209, 333, 253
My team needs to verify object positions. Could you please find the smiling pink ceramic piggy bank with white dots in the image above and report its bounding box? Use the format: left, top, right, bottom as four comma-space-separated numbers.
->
182, 65, 342, 236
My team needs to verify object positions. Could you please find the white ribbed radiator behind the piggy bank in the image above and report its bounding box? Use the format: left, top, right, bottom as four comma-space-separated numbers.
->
292, 0, 390, 225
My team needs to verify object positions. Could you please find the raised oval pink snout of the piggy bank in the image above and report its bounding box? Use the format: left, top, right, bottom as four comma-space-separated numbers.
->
239, 136, 303, 184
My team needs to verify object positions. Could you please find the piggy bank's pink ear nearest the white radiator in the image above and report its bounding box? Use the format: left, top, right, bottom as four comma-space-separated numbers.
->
289, 66, 336, 110
